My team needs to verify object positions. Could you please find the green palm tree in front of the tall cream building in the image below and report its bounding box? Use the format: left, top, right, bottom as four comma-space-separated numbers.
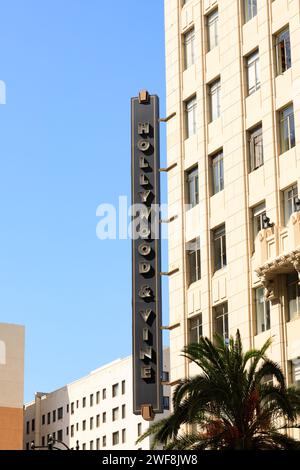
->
138, 331, 300, 450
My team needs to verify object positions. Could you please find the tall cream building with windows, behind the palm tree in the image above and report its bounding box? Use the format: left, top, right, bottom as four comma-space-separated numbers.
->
165, 0, 300, 412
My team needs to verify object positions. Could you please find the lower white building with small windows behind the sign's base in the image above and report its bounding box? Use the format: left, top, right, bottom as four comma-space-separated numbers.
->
24, 350, 170, 450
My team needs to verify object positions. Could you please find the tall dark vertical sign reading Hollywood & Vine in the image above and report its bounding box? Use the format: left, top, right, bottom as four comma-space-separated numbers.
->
131, 91, 162, 419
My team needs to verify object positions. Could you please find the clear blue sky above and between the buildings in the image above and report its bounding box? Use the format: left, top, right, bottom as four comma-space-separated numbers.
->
0, 0, 167, 401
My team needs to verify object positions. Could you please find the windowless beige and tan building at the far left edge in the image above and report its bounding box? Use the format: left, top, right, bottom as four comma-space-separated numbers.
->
0, 323, 24, 450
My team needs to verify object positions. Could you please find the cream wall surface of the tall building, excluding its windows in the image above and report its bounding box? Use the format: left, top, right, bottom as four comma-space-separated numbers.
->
165, 0, 300, 414
